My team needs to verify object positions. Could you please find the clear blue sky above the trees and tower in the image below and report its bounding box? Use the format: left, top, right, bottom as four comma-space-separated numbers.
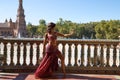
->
0, 0, 120, 25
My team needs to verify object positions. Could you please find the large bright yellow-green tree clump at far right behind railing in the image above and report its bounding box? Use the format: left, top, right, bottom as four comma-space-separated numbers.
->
95, 20, 120, 39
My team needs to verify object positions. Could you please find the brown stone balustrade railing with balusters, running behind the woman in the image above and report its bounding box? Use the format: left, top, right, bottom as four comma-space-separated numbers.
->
0, 38, 120, 74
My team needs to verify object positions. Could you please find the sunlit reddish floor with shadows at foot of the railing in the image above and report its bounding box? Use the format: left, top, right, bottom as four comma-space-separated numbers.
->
0, 72, 120, 80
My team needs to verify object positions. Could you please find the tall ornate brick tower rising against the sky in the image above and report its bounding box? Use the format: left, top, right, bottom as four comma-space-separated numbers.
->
16, 0, 27, 37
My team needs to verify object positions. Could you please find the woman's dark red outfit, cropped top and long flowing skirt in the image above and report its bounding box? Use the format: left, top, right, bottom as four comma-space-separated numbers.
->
35, 32, 61, 78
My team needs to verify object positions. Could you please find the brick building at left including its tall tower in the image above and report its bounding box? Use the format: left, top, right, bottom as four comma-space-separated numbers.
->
0, 0, 27, 37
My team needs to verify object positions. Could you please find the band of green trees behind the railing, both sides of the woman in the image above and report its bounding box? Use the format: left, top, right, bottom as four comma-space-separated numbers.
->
27, 18, 120, 39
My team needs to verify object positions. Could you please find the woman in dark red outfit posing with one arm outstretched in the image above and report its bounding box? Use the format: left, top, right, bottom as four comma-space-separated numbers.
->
35, 22, 73, 78
